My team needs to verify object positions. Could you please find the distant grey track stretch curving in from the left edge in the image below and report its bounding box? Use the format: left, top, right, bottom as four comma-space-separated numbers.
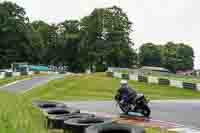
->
0, 74, 64, 93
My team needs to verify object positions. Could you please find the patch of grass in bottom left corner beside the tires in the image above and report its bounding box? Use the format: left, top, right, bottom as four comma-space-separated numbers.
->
0, 92, 47, 133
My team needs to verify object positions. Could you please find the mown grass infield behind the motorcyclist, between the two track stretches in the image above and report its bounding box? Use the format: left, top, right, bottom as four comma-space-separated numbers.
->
24, 73, 200, 100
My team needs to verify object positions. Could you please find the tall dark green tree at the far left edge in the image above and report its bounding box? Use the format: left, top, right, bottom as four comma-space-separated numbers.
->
0, 2, 31, 68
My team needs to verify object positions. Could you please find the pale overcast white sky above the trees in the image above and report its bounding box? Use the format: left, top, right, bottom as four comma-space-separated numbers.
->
5, 0, 200, 69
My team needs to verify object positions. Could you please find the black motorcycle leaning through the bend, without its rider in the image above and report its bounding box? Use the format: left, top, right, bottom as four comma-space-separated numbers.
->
115, 94, 151, 117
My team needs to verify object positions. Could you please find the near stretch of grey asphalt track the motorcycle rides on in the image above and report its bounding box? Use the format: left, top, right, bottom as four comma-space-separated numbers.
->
66, 101, 200, 128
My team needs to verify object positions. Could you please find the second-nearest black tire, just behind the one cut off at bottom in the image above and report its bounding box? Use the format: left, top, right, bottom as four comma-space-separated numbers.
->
64, 117, 108, 133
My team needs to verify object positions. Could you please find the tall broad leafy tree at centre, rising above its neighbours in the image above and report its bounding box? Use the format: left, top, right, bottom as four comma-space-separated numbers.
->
81, 6, 136, 69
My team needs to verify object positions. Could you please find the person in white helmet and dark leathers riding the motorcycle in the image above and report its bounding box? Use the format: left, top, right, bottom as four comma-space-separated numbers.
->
115, 80, 137, 103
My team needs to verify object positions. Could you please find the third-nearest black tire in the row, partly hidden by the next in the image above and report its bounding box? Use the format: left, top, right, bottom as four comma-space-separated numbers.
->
47, 113, 94, 129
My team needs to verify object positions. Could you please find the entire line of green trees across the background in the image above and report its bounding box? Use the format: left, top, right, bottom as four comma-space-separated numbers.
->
0, 2, 193, 72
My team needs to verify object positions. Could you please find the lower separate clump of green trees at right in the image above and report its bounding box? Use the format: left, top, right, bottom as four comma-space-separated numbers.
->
139, 42, 194, 72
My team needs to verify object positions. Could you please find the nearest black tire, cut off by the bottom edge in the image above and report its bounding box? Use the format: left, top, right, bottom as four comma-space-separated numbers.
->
85, 123, 145, 133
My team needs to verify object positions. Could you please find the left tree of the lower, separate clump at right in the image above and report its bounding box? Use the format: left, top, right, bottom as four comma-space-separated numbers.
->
139, 43, 162, 67
